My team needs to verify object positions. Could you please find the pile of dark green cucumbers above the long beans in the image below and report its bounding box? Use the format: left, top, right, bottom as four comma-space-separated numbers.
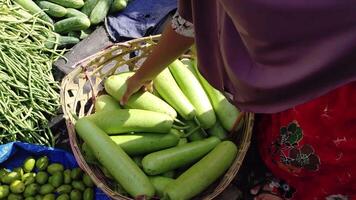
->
13, 0, 128, 47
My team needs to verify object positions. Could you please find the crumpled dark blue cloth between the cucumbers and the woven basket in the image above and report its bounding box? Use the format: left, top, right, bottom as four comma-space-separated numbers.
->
105, 0, 177, 42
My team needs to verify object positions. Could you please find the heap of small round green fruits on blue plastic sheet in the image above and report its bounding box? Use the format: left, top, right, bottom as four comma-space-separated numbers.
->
0, 156, 94, 200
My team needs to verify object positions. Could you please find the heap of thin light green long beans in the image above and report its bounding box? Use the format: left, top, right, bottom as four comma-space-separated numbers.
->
0, 0, 61, 146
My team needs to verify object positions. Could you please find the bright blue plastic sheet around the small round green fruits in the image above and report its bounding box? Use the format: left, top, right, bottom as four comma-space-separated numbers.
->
0, 142, 109, 200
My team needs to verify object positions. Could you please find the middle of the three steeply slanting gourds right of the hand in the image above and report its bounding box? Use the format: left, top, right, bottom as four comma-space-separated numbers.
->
169, 60, 216, 129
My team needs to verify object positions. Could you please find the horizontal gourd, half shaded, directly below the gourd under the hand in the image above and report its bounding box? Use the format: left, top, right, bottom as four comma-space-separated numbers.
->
87, 109, 173, 135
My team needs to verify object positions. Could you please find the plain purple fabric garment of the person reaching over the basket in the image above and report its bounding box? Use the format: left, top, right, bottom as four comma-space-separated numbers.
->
179, 0, 356, 113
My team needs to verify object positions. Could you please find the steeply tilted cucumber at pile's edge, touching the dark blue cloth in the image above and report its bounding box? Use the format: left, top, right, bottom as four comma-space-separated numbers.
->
90, 0, 112, 24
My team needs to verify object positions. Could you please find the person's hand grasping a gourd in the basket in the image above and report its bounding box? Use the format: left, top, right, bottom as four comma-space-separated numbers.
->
120, 75, 153, 106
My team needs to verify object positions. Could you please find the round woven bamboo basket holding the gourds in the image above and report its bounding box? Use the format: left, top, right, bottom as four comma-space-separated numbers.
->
60, 35, 254, 200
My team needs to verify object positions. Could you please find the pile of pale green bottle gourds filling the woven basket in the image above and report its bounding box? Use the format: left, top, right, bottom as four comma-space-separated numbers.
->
75, 59, 242, 200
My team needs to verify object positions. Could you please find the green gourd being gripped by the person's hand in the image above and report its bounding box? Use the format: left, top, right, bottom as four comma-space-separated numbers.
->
104, 72, 177, 118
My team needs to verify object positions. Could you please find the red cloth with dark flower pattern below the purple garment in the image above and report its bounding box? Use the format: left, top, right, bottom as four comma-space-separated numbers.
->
256, 82, 356, 200
